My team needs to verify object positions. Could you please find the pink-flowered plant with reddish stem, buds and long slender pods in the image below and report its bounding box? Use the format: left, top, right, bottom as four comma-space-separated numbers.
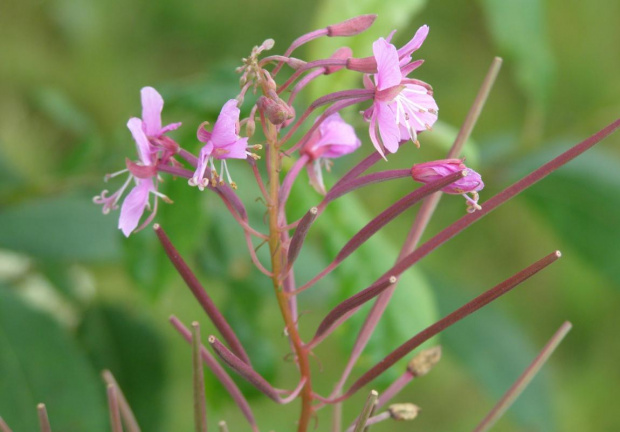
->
7, 11, 618, 431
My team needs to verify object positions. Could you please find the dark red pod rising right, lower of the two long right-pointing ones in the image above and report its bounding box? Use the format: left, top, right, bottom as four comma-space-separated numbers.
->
338, 251, 561, 401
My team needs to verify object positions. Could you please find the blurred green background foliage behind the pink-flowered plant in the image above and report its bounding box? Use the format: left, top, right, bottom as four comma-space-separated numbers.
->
0, 0, 620, 432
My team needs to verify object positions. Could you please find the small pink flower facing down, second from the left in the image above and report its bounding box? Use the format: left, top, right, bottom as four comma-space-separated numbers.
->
189, 99, 249, 190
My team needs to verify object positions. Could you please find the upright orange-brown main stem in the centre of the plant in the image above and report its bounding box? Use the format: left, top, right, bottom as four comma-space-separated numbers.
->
265, 121, 313, 432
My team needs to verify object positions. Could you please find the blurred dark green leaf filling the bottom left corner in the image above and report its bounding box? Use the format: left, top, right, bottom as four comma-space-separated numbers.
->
0, 286, 108, 432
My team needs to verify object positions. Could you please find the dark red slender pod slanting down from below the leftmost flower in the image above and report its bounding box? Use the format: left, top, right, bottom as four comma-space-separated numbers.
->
153, 224, 250, 364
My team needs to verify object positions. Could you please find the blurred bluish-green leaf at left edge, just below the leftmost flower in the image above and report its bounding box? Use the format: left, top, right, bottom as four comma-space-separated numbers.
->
0, 196, 119, 261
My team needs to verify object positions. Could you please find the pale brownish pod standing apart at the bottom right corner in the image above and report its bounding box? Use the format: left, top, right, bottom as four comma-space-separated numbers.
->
474, 321, 572, 432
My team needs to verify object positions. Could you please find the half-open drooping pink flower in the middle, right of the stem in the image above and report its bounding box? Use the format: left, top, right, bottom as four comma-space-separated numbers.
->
301, 113, 361, 195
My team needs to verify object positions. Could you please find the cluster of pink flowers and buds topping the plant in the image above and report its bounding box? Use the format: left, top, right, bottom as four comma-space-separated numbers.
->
94, 21, 483, 236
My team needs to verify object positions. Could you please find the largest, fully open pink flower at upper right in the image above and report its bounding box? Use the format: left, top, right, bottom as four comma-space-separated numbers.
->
364, 30, 438, 158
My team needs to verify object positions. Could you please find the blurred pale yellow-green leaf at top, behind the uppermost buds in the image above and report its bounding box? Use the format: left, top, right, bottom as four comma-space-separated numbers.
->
309, 0, 426, 98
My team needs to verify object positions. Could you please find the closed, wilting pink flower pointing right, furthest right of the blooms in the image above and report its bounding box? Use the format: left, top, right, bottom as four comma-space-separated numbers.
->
411, 159, 484, 213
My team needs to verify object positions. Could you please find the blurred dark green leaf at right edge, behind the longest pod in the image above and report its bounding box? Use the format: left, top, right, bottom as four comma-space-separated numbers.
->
515, 148, 620, 287
